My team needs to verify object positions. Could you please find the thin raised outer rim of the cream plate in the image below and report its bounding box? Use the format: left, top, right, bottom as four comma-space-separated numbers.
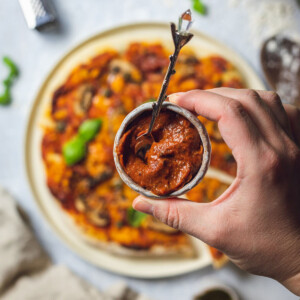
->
23, 22, 265, 279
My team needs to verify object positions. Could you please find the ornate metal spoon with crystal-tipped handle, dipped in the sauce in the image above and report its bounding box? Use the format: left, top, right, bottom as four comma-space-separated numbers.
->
134, 9, 193, 159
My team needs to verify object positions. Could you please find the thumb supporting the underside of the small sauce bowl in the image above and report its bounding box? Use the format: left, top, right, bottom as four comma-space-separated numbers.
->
133, 196, 218, 245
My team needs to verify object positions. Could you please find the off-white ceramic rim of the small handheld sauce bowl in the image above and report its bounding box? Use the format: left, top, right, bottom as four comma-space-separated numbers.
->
113, 102, 211, 199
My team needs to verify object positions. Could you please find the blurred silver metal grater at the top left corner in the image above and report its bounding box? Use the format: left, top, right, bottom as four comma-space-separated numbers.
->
19, 0, 56, 29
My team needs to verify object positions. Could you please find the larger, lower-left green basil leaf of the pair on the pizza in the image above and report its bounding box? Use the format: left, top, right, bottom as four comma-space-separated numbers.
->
62, 136, 86, 166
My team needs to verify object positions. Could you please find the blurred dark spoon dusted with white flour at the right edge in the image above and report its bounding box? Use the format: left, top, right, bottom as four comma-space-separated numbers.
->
261, 35, 300, 107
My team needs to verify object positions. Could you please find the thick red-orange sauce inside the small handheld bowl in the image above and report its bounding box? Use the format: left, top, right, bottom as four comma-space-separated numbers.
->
117, 110, 203, 195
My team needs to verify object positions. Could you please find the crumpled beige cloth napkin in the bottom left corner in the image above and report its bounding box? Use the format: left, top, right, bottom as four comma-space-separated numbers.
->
0, 188, 149, 300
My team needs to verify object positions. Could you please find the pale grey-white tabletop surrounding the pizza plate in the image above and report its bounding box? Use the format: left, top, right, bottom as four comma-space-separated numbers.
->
0, 0, 297, 300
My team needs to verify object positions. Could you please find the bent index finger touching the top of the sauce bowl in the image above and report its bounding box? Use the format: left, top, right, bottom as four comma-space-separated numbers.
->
169, 90, 261, 170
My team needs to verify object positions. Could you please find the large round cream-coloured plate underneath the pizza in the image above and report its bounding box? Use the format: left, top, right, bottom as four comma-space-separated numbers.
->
25, 23, 264, 278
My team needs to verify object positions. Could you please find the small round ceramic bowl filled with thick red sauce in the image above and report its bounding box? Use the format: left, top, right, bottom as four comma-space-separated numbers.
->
113, 102, 211, 199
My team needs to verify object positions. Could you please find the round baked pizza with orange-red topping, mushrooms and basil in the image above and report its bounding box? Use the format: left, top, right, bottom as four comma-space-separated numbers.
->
41, 42, 243, 261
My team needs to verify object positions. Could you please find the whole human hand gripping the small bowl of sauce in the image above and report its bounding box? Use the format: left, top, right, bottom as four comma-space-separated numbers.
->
133, 88, 300, 296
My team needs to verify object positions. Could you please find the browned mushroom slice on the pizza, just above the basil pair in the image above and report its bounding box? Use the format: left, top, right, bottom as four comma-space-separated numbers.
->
74, 84, 95, 116
